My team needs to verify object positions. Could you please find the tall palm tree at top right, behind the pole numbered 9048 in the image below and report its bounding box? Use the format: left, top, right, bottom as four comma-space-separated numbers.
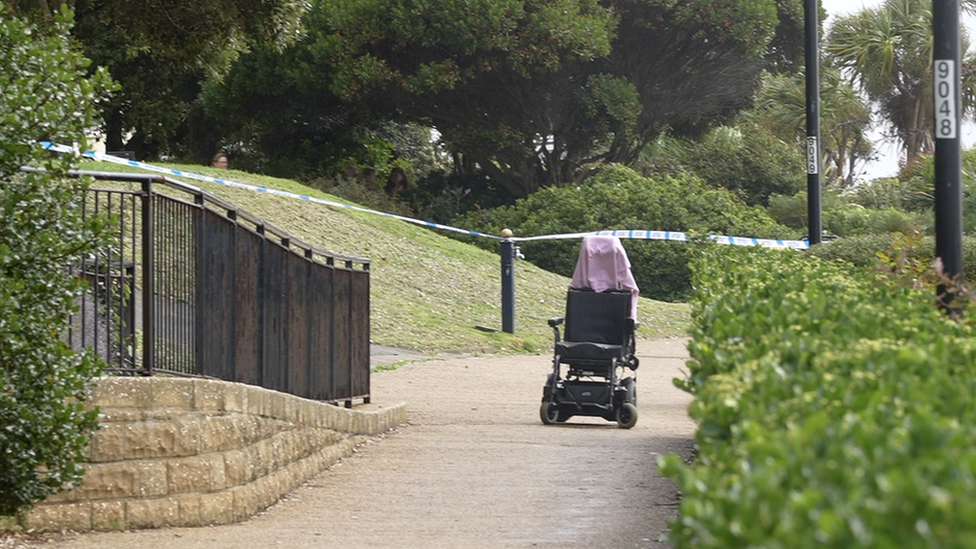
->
827, 0, 976, 165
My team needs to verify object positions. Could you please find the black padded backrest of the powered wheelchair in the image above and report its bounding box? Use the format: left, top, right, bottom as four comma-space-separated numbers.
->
563, 288, 631, 345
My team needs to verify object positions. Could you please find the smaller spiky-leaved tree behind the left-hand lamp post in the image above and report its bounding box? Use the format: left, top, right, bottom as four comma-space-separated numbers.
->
744, 67, 873, 186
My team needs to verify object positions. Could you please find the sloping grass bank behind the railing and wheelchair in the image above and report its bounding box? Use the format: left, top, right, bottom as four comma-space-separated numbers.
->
80, 162, 688, 353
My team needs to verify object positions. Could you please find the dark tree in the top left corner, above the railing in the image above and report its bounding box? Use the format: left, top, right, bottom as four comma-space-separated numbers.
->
7, 0, 305, 158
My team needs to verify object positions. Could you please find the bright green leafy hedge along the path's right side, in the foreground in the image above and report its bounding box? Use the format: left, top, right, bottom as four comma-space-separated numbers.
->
661, 248, 976, 549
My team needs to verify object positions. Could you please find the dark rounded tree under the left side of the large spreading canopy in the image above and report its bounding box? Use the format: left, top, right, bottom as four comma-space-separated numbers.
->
203, 41, 404, 179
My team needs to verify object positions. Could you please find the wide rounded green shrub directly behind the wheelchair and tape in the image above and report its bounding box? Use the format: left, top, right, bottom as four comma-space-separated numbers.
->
455, 166, 796, 301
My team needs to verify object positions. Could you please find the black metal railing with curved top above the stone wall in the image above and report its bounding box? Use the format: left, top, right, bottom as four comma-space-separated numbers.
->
36, 171, 370, 405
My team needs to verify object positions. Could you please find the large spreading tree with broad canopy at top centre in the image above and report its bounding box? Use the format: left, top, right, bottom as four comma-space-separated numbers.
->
223, 0, 802, 196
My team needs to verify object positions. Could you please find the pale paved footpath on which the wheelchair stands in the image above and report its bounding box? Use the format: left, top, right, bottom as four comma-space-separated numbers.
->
43, 339, 694, 549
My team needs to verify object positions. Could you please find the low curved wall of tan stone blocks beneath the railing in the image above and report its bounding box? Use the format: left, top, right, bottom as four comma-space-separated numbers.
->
0, 377, 407, 531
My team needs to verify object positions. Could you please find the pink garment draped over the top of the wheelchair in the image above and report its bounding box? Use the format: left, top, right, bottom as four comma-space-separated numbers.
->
570, 236, 640, 320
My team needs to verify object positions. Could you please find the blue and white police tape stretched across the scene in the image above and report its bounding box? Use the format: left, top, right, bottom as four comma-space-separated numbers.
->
40, 141, 810, 250
